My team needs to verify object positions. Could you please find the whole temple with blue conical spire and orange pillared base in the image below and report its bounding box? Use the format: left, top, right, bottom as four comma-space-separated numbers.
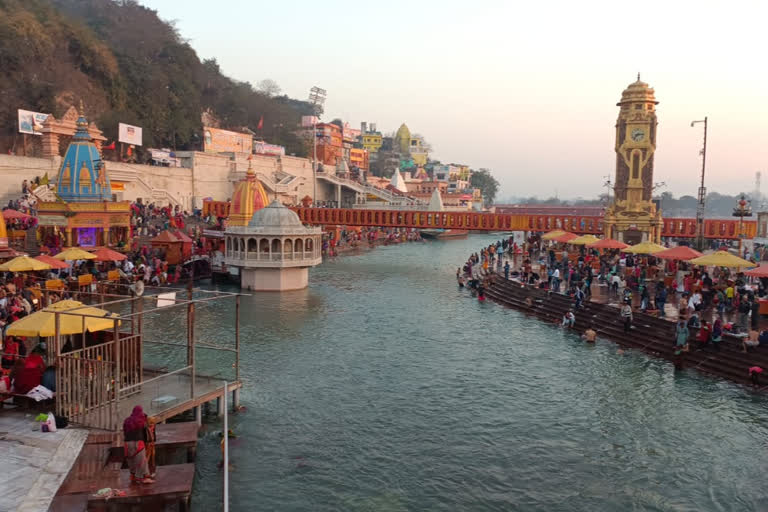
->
38, 106, 130, 247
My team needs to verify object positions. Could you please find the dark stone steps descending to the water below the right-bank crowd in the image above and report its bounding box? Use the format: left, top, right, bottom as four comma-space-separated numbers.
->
486, 274, 768, 391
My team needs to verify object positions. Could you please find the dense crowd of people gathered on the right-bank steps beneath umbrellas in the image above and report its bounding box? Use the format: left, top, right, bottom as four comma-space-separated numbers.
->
456, 234, 768, 381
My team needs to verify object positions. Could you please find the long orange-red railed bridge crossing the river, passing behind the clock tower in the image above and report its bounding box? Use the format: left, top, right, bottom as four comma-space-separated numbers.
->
293, 207, 757, 240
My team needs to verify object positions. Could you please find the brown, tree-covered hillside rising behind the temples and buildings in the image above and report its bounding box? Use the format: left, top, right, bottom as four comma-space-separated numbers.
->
0, 0, 312, 155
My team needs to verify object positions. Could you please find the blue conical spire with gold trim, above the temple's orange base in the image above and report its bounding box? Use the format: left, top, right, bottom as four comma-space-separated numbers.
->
56, 107, 112, 202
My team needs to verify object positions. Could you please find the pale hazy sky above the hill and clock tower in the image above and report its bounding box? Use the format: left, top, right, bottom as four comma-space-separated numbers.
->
142, 0, 768, 198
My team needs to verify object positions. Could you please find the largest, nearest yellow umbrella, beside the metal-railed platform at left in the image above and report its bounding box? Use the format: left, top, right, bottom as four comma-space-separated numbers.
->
6, 300, 120, 338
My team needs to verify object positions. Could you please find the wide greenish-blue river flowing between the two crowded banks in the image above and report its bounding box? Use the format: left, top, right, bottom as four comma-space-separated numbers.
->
152, 235, 768, 512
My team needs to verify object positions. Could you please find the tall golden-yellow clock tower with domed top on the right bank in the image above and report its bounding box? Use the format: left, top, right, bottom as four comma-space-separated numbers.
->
604, 74, 662, 244
